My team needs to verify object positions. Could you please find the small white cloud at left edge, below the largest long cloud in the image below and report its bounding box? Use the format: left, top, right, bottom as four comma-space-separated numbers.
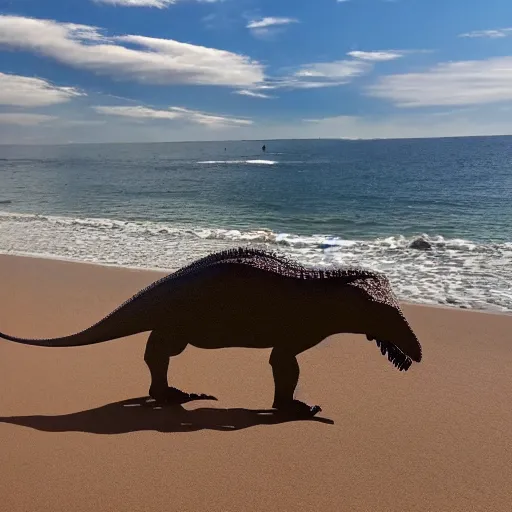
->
0, 72, 83, 107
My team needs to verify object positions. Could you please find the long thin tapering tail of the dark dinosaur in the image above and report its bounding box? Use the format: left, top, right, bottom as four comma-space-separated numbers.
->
0, 288, 158, 347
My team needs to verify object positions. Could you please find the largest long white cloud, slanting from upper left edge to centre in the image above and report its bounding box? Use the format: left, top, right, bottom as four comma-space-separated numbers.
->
0, 15, 264, 88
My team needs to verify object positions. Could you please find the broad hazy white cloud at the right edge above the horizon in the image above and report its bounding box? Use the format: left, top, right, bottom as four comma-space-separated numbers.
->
368, 57, 512, 107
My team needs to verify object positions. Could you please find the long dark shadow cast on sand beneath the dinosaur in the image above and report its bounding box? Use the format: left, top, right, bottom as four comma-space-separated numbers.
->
0, 397, 334, 434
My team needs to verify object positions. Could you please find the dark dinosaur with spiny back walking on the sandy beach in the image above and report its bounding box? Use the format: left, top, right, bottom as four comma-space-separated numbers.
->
0, 248, 422, 416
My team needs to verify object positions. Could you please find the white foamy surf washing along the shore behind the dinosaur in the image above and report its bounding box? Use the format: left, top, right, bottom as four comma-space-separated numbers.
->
0, 212, 512, 311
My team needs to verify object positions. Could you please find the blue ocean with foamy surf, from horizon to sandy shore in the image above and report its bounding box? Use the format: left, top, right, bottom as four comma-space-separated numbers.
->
0, 137, 512, 312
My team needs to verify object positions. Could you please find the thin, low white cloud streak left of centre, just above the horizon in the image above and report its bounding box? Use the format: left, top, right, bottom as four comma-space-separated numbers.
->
93, 106, 252, 128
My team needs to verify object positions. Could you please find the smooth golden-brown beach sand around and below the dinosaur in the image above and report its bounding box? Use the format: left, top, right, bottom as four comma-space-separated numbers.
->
0, 256, 512, 512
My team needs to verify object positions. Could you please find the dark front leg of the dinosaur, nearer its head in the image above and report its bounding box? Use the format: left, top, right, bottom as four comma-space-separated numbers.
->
269, 348, 322, 416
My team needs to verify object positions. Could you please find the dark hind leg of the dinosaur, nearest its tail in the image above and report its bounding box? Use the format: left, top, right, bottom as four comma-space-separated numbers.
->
144, 330, 216, 404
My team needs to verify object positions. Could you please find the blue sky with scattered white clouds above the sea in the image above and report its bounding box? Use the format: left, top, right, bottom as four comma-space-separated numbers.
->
0, 0, 512, 144
